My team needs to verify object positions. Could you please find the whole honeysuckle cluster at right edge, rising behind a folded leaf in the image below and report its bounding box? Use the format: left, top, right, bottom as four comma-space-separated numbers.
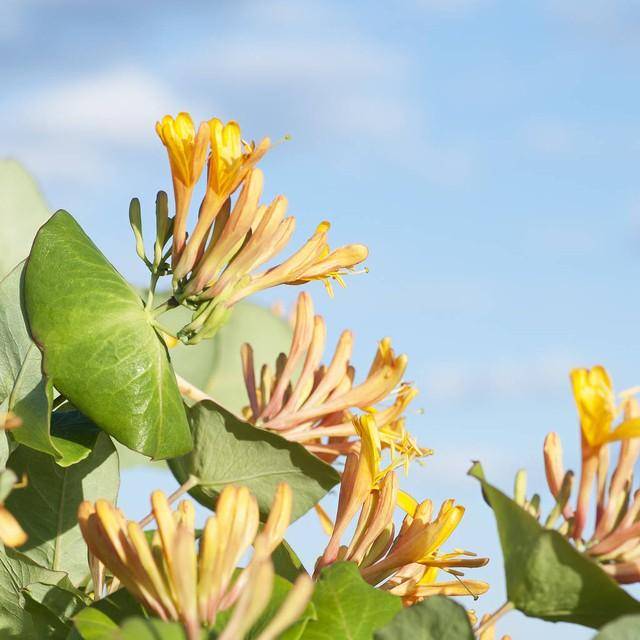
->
536, 366, 640, 583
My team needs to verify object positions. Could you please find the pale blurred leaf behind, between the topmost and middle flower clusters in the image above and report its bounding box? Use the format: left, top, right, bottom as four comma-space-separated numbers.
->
162, 302, 292, 415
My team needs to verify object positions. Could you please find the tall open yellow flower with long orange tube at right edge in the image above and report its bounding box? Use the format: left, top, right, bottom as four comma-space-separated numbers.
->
571, 365, 640, 540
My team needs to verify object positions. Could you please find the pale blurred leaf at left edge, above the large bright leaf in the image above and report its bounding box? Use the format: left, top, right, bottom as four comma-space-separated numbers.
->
0, 160, 51, 279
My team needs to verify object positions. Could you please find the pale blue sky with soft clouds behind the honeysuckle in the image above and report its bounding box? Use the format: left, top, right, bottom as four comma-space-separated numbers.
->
6, 0, 640, 638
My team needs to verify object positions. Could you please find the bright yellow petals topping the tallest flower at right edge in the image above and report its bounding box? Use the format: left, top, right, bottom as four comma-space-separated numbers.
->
571, 365, 640, 448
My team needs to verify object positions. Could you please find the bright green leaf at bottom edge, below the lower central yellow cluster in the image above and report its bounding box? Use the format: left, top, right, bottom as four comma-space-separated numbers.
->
302, 562, 402, 640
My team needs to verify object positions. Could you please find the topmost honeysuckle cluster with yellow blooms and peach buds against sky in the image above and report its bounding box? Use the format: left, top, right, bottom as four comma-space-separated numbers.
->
156, 113, 368, 343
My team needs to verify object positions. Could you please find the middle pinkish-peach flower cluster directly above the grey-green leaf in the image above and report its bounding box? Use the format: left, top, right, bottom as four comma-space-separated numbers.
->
241, 293, 430, 462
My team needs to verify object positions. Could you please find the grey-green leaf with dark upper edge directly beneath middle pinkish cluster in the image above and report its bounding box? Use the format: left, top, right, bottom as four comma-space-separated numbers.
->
169, 400, 340, 519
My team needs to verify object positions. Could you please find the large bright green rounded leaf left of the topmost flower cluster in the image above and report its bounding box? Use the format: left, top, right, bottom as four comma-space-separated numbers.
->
25, 211, 191, 458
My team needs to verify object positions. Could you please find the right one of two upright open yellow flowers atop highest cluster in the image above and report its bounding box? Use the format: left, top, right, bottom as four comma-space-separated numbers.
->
175, 118, 271, 279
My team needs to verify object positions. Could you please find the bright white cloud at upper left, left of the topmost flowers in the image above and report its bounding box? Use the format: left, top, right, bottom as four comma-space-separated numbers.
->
0, 66, 202, 185
